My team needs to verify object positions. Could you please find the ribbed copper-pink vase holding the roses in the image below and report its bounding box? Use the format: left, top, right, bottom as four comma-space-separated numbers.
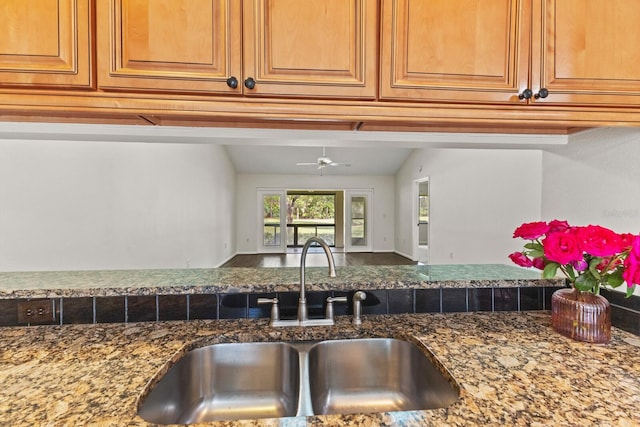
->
551, 288, 611, 343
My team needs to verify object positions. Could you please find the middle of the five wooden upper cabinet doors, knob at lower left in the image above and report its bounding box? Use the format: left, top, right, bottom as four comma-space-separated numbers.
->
243, 0, 378, 98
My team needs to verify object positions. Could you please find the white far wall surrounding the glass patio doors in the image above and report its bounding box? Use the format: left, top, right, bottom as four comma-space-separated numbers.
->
236, 174, 395, 253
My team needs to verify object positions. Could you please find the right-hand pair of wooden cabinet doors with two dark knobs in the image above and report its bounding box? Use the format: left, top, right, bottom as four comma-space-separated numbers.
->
381, 0, 640, 107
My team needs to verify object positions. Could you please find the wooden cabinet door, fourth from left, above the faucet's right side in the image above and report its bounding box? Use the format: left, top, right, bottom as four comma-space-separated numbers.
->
381, 0, 531, 103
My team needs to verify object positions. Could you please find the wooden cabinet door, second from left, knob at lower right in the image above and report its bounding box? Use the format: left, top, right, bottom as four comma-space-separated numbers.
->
97, 0, 241, 93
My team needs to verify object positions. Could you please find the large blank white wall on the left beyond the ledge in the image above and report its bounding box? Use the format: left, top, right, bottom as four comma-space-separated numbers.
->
0, 141, 235, 271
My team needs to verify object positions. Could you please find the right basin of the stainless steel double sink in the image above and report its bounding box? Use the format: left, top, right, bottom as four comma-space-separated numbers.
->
309, 338, 459, 415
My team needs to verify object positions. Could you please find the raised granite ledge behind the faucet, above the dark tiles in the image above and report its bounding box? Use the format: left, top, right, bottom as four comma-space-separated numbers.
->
0, 264, 562, 299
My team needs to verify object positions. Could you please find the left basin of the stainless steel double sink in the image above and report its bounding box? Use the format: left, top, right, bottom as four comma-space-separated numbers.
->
138, 342, 300, 424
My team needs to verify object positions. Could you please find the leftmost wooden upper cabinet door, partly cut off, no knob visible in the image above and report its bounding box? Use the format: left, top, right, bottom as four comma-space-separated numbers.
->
0, 0, 92, 89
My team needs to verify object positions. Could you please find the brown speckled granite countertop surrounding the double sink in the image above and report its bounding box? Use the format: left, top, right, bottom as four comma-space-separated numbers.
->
0, 312, 640, 427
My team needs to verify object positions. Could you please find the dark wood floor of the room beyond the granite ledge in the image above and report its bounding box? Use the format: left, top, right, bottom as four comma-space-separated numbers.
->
221, 250, 417, 268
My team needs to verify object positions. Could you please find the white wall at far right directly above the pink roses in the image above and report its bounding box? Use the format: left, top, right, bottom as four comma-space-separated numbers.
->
542, 128, 640, 234
